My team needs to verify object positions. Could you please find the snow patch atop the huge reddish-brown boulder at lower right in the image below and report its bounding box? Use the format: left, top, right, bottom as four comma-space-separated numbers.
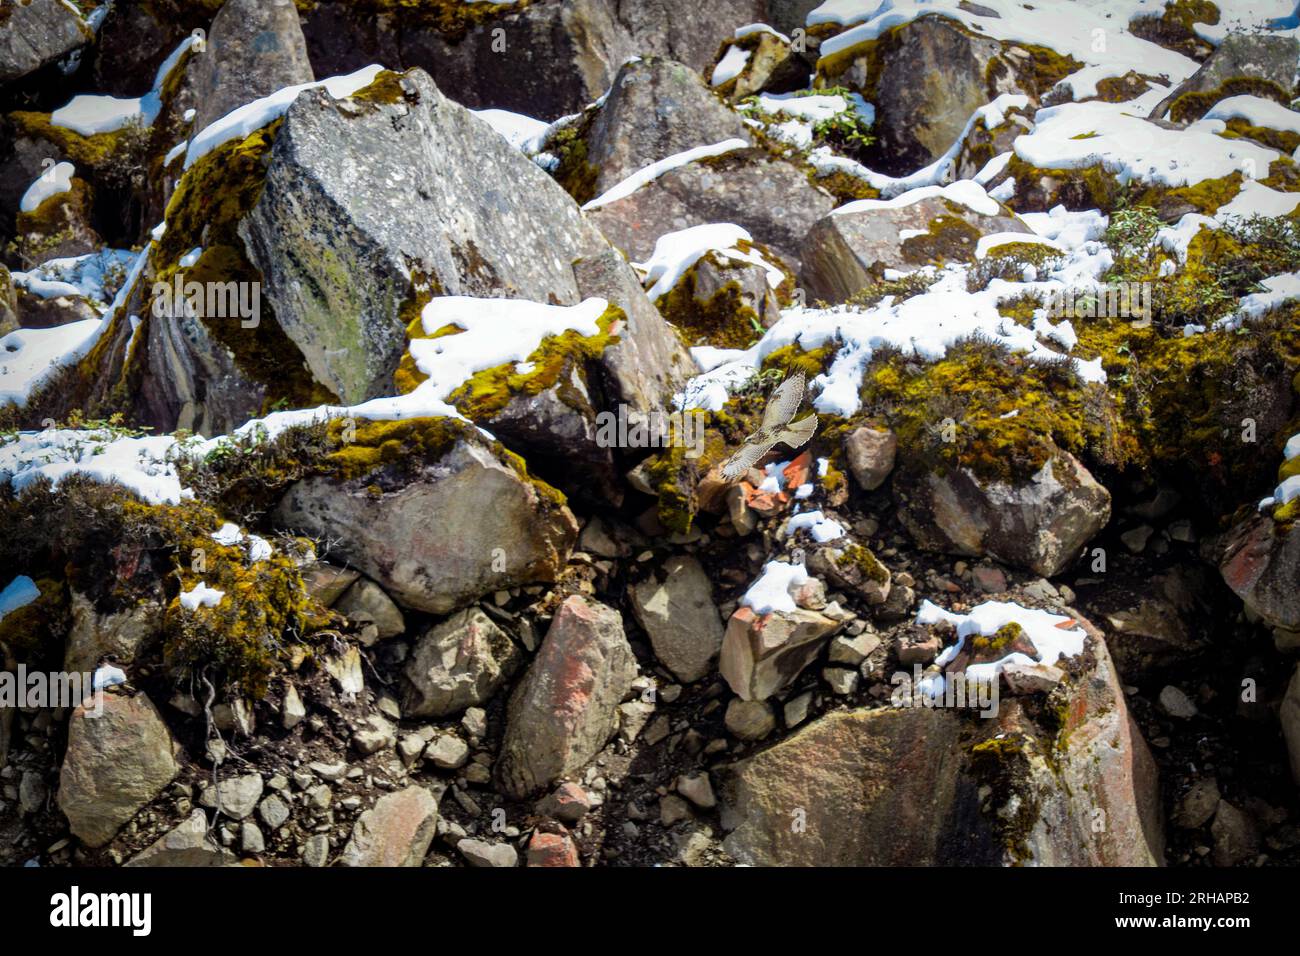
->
917, 601, 1087, 682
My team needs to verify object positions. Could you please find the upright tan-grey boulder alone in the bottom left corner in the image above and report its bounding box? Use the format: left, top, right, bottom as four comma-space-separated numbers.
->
59, 693, 181, 847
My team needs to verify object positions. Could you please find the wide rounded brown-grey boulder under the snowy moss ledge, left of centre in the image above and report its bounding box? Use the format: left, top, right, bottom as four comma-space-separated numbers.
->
276, 419, 577, 614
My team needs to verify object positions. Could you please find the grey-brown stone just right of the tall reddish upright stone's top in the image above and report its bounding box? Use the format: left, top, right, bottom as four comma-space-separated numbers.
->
632, 555, 723, 683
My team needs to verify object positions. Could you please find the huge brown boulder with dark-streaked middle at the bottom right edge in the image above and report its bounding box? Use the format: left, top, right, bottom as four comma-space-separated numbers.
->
714, 613, 1164, 866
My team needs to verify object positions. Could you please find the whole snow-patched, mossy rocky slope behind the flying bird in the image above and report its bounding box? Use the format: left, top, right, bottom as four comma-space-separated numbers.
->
0, 0, 1300, 866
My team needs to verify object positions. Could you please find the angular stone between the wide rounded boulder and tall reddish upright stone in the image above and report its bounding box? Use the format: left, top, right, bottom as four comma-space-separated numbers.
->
403, 607, 524, 717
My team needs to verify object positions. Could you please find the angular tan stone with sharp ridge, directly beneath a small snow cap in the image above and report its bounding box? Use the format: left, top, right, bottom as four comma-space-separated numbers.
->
718, 607, 840, 701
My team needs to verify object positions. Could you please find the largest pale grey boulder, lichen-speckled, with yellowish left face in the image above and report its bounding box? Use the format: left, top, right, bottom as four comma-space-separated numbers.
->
239, 70, 605, 402
